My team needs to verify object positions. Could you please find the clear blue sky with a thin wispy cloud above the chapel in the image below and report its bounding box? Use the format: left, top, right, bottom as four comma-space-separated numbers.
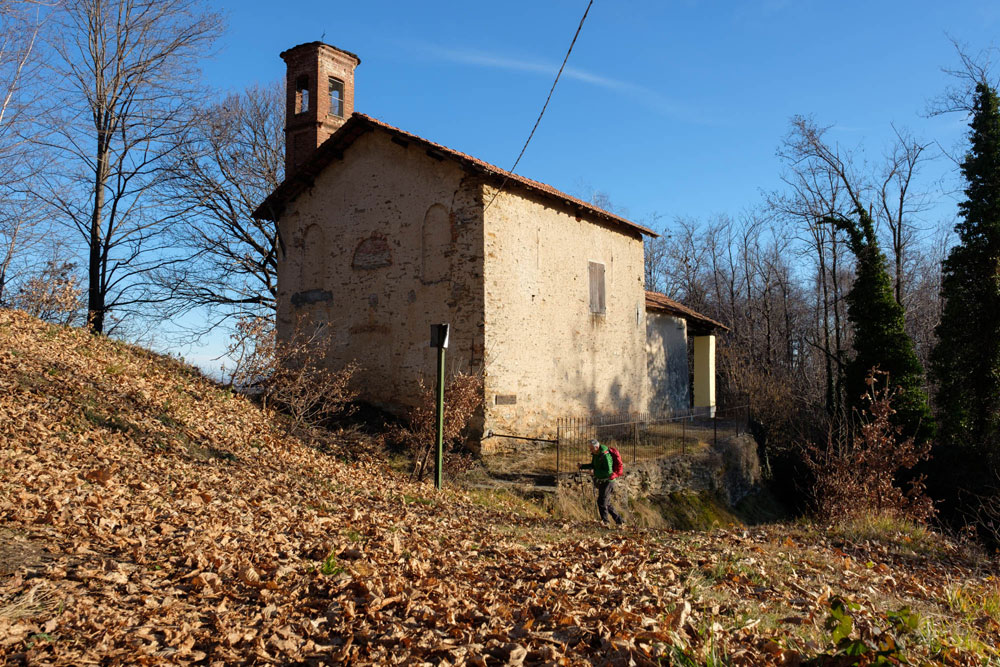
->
180, 0, 1000, 376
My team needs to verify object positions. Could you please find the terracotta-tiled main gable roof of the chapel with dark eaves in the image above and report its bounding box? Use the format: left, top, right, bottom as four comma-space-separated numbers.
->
253, 112, 658, 236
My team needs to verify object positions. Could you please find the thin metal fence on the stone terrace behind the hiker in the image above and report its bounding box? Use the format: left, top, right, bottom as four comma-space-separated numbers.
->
555, 405, 749, 474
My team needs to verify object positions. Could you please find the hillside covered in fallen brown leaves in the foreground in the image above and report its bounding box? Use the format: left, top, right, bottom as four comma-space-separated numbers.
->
0, 310, 1000, 665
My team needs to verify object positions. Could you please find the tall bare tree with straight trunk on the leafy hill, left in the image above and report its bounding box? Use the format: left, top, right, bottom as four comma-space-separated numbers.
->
38, 0, 222, 333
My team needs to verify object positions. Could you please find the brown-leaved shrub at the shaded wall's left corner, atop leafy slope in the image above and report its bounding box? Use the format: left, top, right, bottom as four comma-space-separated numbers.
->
229, 317, 358, 432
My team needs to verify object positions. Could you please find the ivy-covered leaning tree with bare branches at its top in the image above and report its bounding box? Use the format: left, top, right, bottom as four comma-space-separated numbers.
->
830, 205, 934, 443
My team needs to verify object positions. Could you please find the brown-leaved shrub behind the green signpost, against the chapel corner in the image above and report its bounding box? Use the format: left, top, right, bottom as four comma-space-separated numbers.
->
390, 373, 483, 480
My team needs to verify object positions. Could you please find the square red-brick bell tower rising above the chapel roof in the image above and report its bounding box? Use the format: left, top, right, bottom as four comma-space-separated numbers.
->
281, 42, 361, 179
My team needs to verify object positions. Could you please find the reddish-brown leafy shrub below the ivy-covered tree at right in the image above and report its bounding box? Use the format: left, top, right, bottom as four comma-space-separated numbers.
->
804, 370, 935, 521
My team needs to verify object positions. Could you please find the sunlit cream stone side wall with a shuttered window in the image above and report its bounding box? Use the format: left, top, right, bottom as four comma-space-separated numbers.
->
483, 187, 647, 444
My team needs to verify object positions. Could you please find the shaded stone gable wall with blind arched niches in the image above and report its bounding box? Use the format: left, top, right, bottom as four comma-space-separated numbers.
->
278, 130, 483, 408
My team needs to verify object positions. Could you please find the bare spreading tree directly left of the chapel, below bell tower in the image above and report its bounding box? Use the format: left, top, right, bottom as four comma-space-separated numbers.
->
158, 84, 285, 327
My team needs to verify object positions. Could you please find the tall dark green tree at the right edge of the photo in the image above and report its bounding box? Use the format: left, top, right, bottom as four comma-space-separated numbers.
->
931, 82, 1000, 456
